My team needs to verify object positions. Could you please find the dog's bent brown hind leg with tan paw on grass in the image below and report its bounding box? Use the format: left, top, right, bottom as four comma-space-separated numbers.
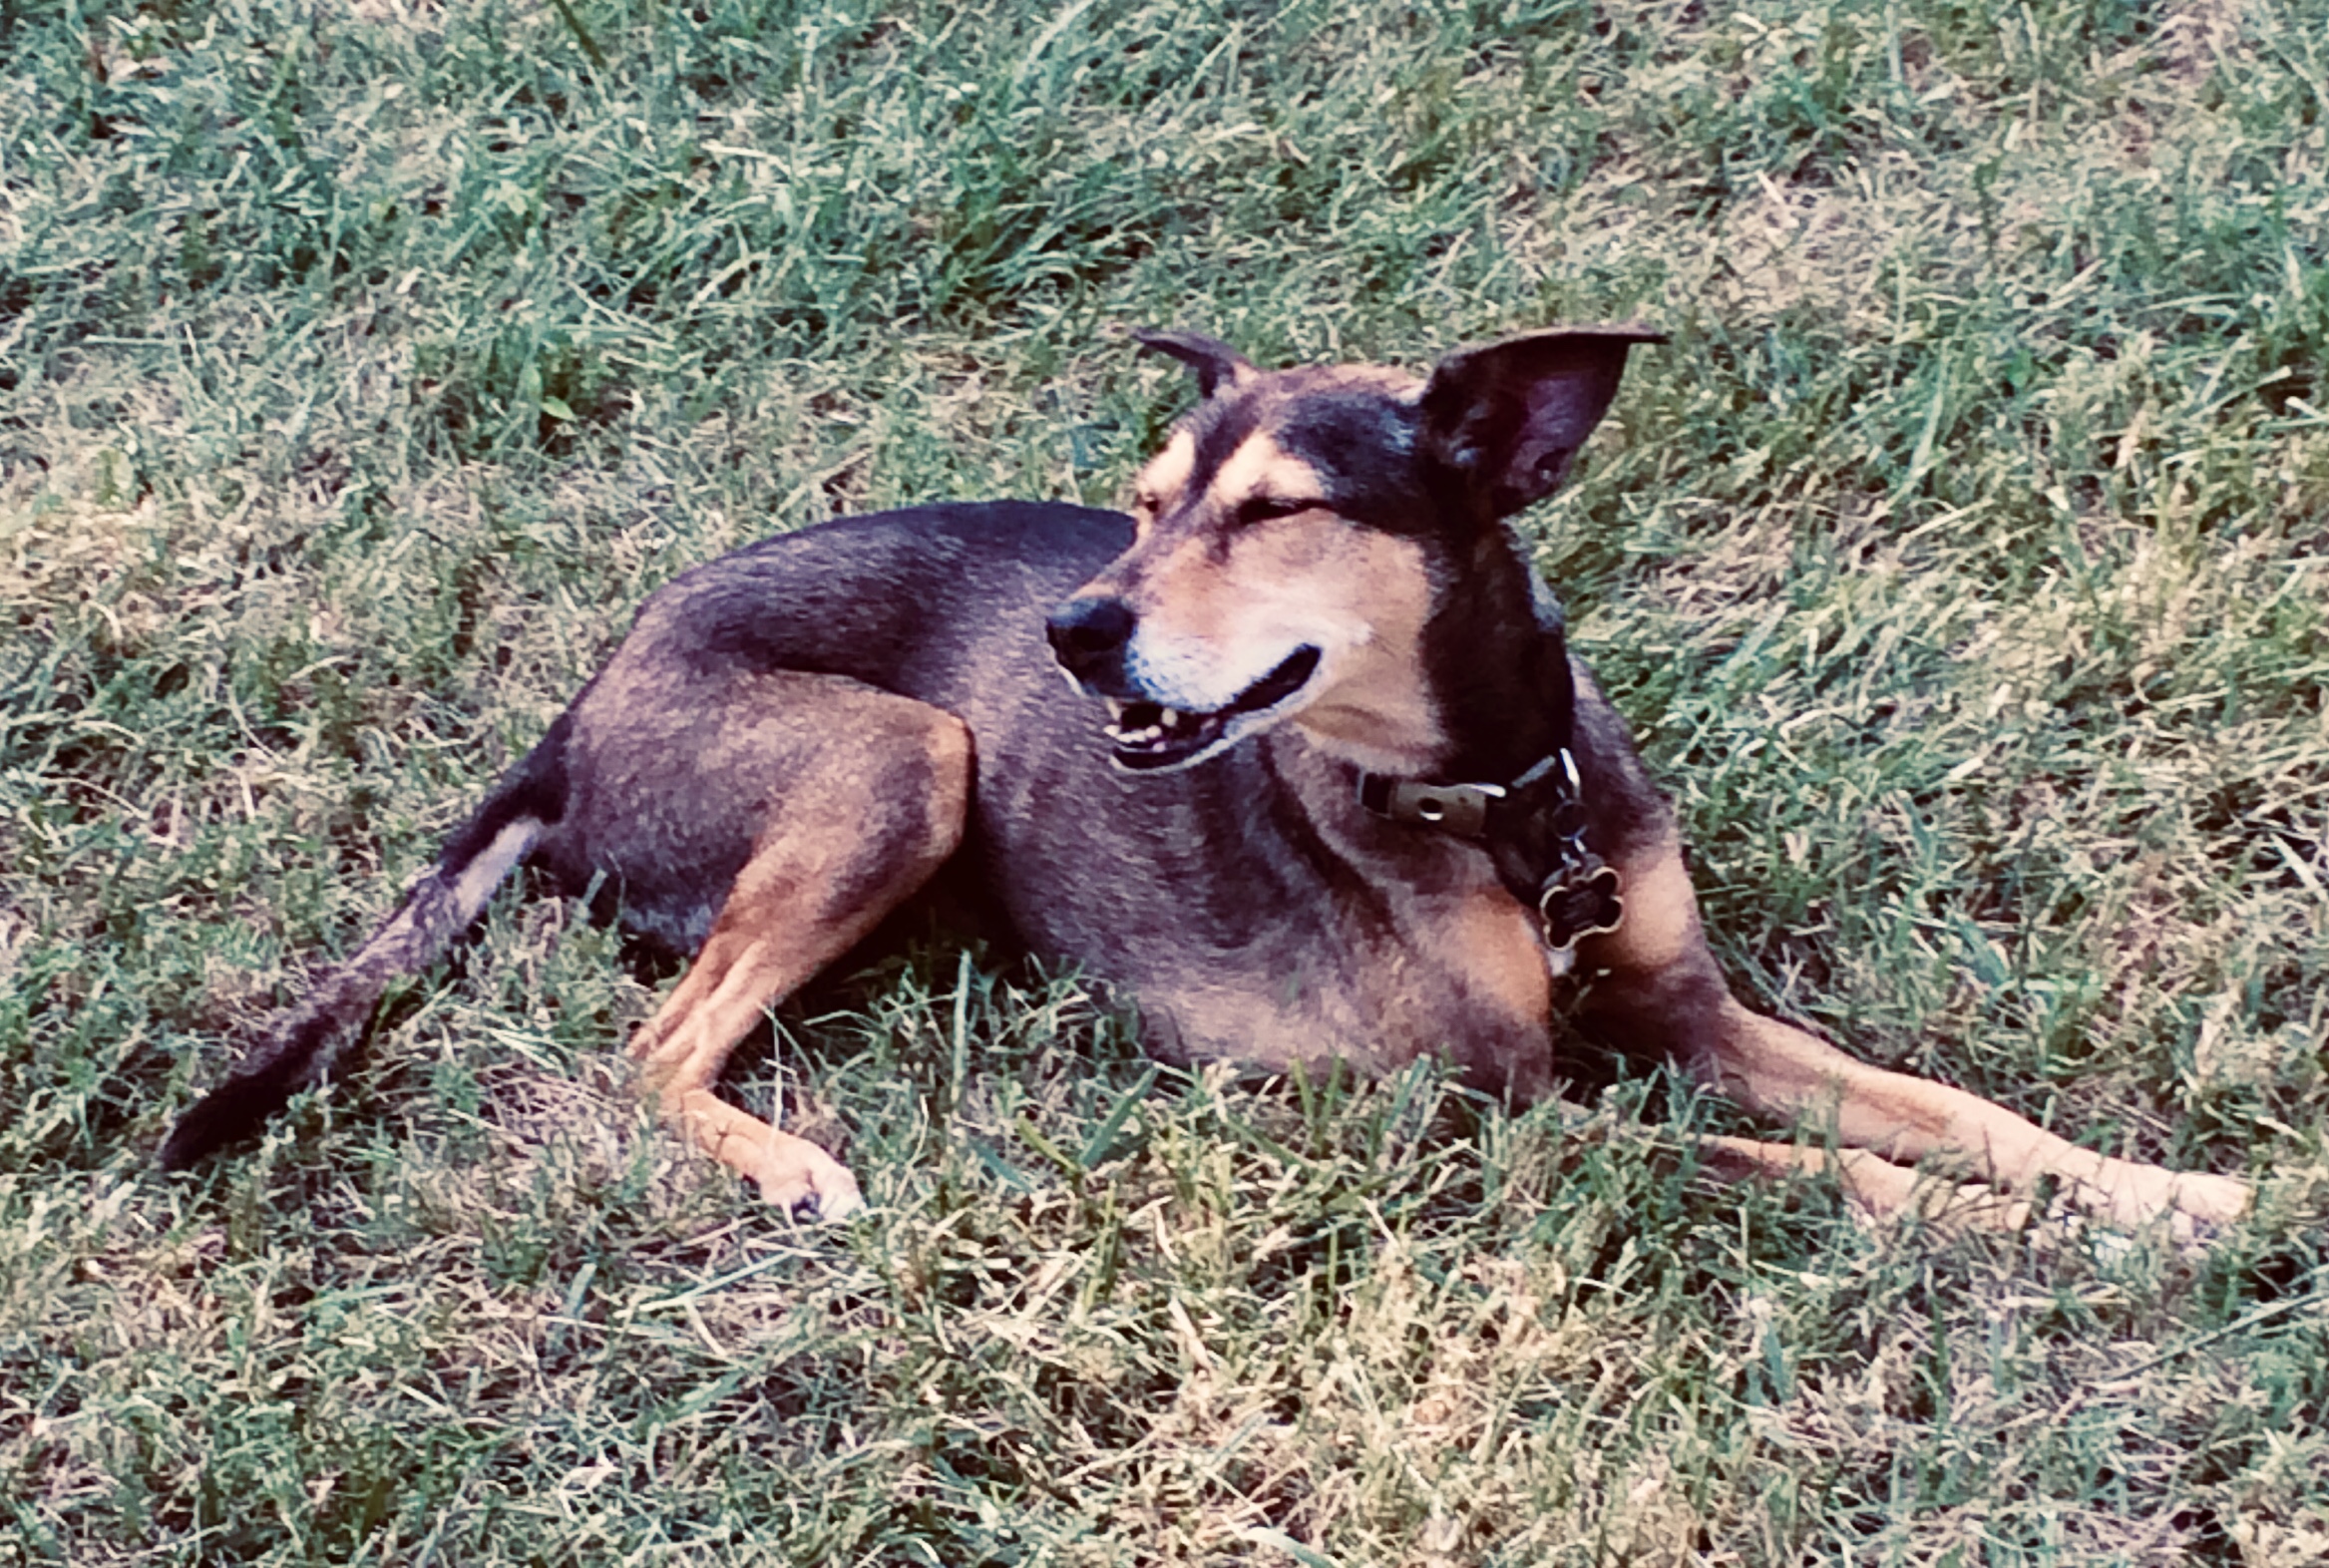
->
578, 673, 971, 1219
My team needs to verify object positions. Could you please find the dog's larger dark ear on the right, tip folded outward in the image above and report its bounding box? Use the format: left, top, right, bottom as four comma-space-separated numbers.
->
1423, 326, 1666, 518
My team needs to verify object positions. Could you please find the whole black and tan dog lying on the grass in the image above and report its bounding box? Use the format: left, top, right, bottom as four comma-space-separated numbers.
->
161, 326, 2250, 1235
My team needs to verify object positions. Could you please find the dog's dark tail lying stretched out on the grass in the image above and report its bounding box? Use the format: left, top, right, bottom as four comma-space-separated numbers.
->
156, 720, 566, 1170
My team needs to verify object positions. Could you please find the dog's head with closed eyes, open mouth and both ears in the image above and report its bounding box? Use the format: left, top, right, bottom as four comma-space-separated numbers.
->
1050, 326, 1661, 771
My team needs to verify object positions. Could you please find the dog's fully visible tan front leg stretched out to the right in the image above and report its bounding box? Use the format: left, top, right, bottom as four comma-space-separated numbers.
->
1579, 834, 2250, 1233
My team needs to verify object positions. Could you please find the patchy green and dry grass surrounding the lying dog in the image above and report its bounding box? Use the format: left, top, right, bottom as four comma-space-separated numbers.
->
0, 0, 2329, 1568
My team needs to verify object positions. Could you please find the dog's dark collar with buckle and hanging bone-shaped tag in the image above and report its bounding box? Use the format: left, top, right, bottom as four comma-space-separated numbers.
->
1358, 745, 1626, 956
